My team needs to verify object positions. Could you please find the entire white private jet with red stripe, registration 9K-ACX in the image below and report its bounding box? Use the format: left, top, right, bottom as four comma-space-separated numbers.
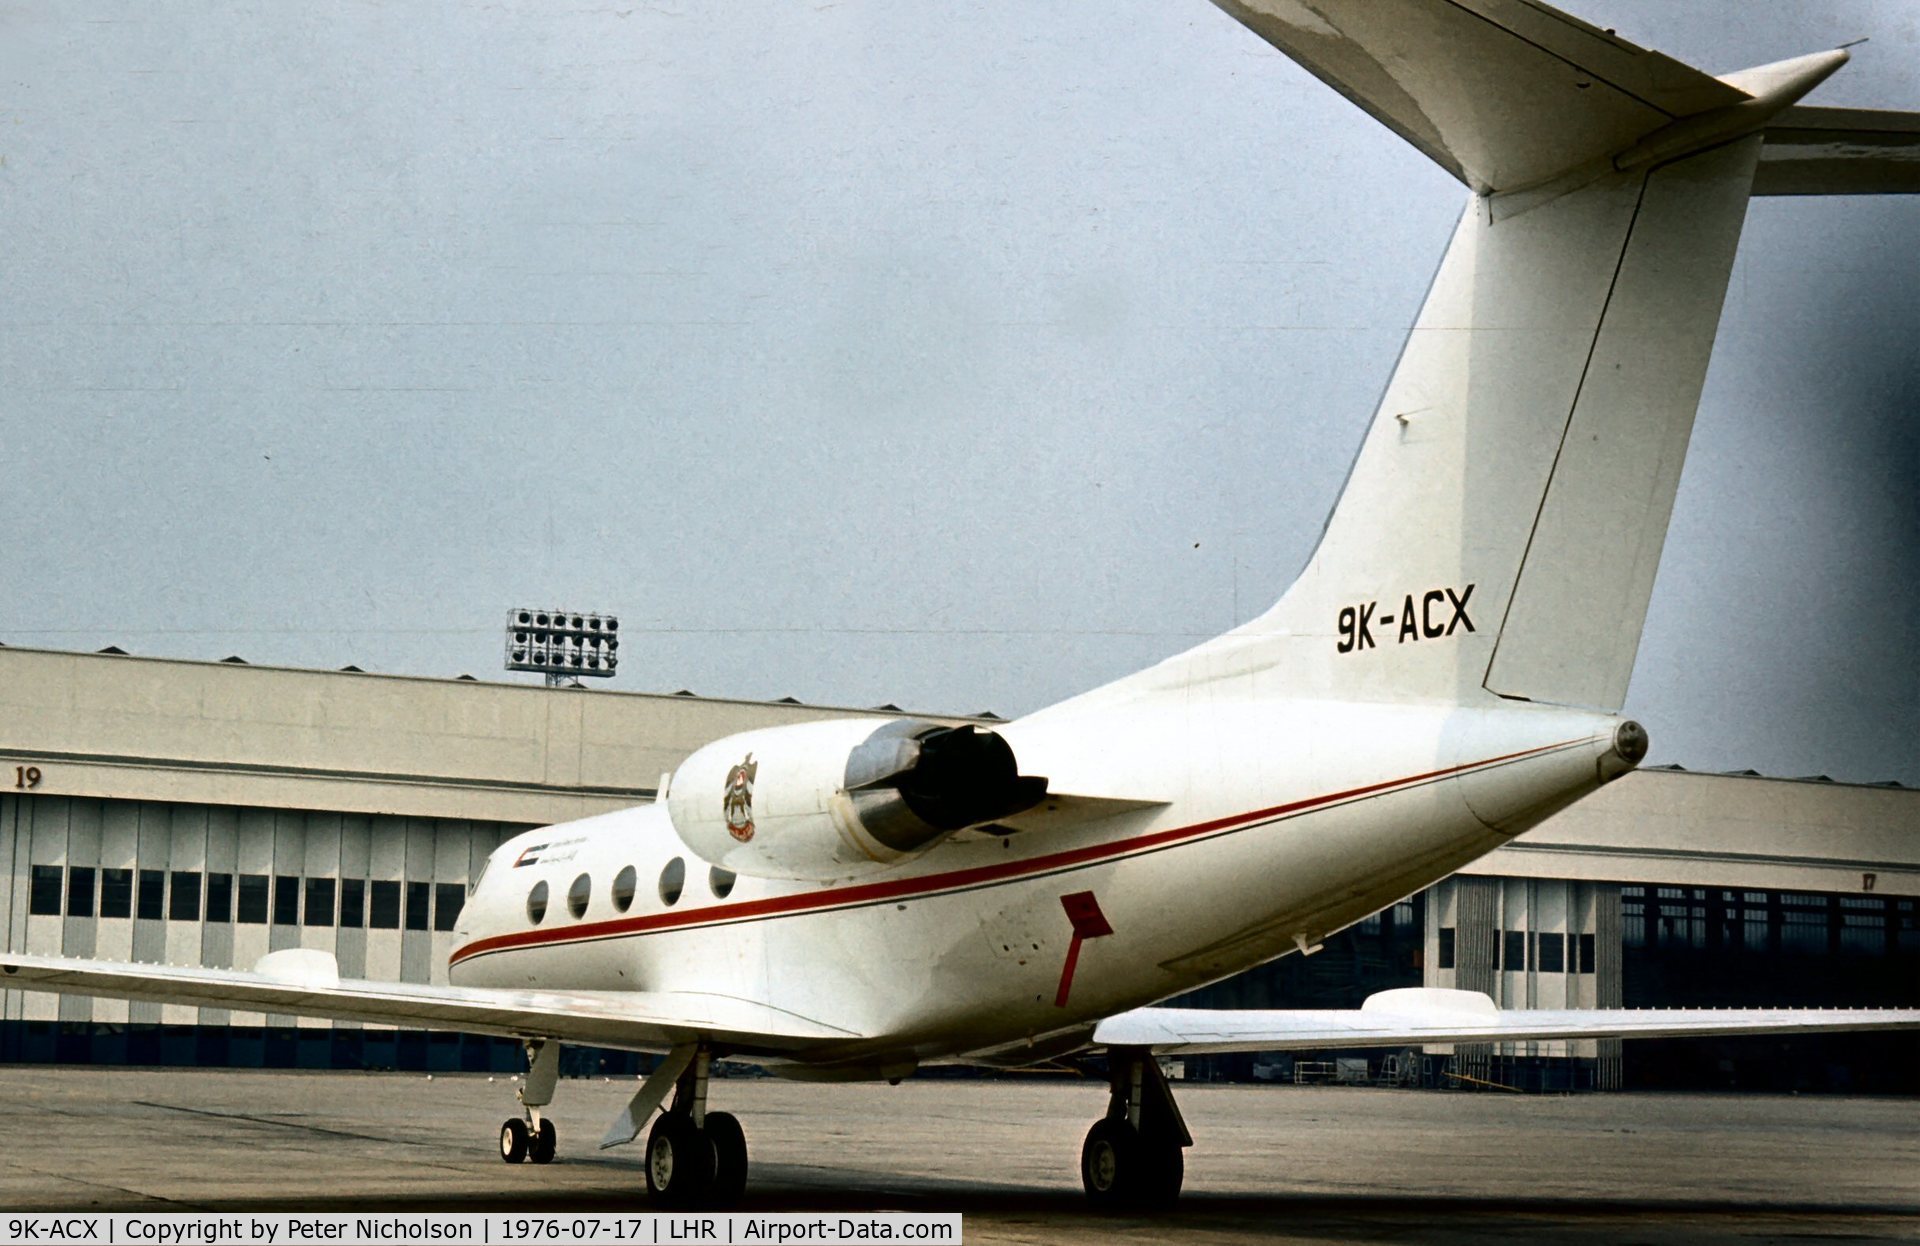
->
0, 0, 1920, 1206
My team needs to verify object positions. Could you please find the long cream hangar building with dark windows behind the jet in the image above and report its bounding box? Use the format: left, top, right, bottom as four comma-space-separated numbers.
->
0, 647, 1920, 1090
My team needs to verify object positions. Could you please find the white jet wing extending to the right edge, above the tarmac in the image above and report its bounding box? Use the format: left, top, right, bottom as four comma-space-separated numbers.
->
1092, 987, 1920, 1054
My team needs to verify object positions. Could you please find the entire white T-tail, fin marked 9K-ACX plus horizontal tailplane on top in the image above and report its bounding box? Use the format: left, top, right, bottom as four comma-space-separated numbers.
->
1067, 0, 1920, 710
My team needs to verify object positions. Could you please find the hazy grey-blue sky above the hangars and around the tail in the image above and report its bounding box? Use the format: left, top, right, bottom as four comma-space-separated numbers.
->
0, 0, 1920, 783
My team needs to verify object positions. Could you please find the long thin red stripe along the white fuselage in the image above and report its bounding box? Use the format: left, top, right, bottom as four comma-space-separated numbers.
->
447, 739, 1586, 966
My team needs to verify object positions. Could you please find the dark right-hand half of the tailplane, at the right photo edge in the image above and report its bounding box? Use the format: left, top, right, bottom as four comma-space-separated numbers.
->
1753, 104, 1920, 194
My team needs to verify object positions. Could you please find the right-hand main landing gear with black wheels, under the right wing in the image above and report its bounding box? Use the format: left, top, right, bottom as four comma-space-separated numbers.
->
1081, 1046, 1194, 1211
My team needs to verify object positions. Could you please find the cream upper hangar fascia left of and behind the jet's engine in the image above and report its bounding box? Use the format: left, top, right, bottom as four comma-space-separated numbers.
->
0, 647, 956, 824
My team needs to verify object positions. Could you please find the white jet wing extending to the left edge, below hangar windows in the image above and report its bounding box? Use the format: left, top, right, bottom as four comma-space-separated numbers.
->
0, 948, 860, 1054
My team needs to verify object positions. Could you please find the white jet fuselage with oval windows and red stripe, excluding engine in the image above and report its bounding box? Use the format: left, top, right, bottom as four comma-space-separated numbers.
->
451, 703, 1628, 1077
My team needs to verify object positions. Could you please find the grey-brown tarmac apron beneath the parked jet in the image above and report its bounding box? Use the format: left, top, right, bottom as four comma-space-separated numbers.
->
0, 1066, 1920, 1242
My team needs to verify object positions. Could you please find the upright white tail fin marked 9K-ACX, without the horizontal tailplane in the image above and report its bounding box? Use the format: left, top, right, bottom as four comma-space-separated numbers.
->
1223, 136, 1761, 710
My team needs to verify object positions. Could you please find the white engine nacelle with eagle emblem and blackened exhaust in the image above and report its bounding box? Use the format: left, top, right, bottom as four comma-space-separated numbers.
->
666, 718, 1046, 881
